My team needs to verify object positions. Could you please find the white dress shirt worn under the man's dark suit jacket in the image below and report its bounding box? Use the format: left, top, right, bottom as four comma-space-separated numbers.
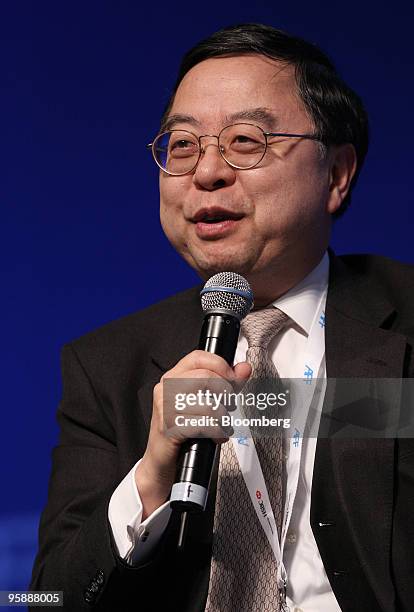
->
108, 254, 340, 612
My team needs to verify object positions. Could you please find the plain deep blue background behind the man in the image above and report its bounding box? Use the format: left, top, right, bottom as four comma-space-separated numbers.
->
0, 0, 414, 589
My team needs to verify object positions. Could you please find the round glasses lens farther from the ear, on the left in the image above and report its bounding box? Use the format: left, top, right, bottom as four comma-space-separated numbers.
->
153, 130, 199, 175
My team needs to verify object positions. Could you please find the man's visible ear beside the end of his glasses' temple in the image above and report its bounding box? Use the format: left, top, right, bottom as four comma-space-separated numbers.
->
327, 143, 357, 214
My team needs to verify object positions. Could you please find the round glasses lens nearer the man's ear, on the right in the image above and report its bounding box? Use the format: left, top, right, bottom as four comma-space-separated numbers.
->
219, 123, 266, 168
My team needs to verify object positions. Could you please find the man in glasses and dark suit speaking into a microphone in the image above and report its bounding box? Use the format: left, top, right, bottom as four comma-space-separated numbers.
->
32, 24, 414, 612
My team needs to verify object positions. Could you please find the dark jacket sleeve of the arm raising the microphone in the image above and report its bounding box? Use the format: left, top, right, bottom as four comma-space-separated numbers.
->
30, 345, 178, 612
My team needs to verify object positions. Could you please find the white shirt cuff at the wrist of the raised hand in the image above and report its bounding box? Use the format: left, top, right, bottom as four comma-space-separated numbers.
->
108, 459, 171, 565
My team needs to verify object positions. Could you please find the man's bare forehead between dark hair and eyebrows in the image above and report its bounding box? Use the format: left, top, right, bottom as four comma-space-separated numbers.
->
169, 55, 306, 127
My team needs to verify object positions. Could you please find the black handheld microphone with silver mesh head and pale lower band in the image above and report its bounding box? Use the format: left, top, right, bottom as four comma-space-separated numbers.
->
170, 272, 253, 548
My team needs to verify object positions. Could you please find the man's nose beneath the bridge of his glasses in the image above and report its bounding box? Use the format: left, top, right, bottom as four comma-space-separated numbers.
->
193, 136, 236, 191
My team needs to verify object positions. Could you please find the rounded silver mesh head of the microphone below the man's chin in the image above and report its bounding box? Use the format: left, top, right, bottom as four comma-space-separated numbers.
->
201, 272, 253, 319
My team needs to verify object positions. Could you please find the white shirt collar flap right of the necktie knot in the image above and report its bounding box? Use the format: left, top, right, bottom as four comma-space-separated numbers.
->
273, 252, 329, 335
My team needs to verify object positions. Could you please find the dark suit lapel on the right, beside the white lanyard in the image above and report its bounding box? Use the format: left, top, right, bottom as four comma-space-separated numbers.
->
311, 255, 406, 609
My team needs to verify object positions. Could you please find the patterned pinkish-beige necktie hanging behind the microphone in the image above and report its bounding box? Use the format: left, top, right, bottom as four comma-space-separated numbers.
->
205, 307, 290, 612
